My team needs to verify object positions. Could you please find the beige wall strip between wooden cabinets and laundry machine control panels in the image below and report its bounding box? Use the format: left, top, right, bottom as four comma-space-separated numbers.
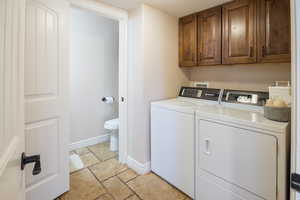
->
184, 63, 291, 91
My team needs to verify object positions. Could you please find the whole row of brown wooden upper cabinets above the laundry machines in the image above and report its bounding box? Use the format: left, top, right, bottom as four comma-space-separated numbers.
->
179, 0, 291, 67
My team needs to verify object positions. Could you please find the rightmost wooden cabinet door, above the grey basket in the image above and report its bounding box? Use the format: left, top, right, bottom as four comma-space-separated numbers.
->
258, 0, 291, 62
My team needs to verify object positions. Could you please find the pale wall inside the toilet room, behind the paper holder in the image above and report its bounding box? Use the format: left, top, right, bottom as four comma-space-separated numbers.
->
70, 8, 119, 143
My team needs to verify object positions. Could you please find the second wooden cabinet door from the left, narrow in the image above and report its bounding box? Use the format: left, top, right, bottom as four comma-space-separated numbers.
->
198, 7, 222, 65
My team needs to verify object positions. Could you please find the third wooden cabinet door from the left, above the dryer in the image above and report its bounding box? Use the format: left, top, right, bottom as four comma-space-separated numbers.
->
222, 0, 256, 64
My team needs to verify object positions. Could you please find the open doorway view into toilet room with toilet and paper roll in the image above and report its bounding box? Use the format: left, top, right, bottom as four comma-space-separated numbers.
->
69, 7, 119, 171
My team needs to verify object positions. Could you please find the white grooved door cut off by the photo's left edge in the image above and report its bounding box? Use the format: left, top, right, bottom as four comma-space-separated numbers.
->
0, 0, 25, 200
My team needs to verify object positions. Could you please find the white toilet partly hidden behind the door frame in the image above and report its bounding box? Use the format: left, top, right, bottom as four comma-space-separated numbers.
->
104, 118, 119, 151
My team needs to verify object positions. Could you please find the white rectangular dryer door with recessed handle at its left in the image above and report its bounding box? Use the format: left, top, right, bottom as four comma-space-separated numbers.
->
197, 120, 277, 199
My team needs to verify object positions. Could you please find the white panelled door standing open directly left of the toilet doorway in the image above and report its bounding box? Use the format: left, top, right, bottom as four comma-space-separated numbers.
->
24, 0, 69, 200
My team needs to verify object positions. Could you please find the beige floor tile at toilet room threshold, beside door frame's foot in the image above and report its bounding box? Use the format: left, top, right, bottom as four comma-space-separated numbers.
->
90, 158, 127, 181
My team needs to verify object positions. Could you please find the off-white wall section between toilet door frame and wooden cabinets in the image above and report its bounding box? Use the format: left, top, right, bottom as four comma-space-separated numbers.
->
128, 5, 188, 164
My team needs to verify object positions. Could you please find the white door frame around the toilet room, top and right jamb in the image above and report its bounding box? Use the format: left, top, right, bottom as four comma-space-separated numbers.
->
69, 0, 128, 163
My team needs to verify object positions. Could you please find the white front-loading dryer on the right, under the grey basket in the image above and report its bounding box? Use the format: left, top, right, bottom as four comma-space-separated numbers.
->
196, 90, 290, 200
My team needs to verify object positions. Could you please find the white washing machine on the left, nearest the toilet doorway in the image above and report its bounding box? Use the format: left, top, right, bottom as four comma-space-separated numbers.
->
151, 87, 221, 199
